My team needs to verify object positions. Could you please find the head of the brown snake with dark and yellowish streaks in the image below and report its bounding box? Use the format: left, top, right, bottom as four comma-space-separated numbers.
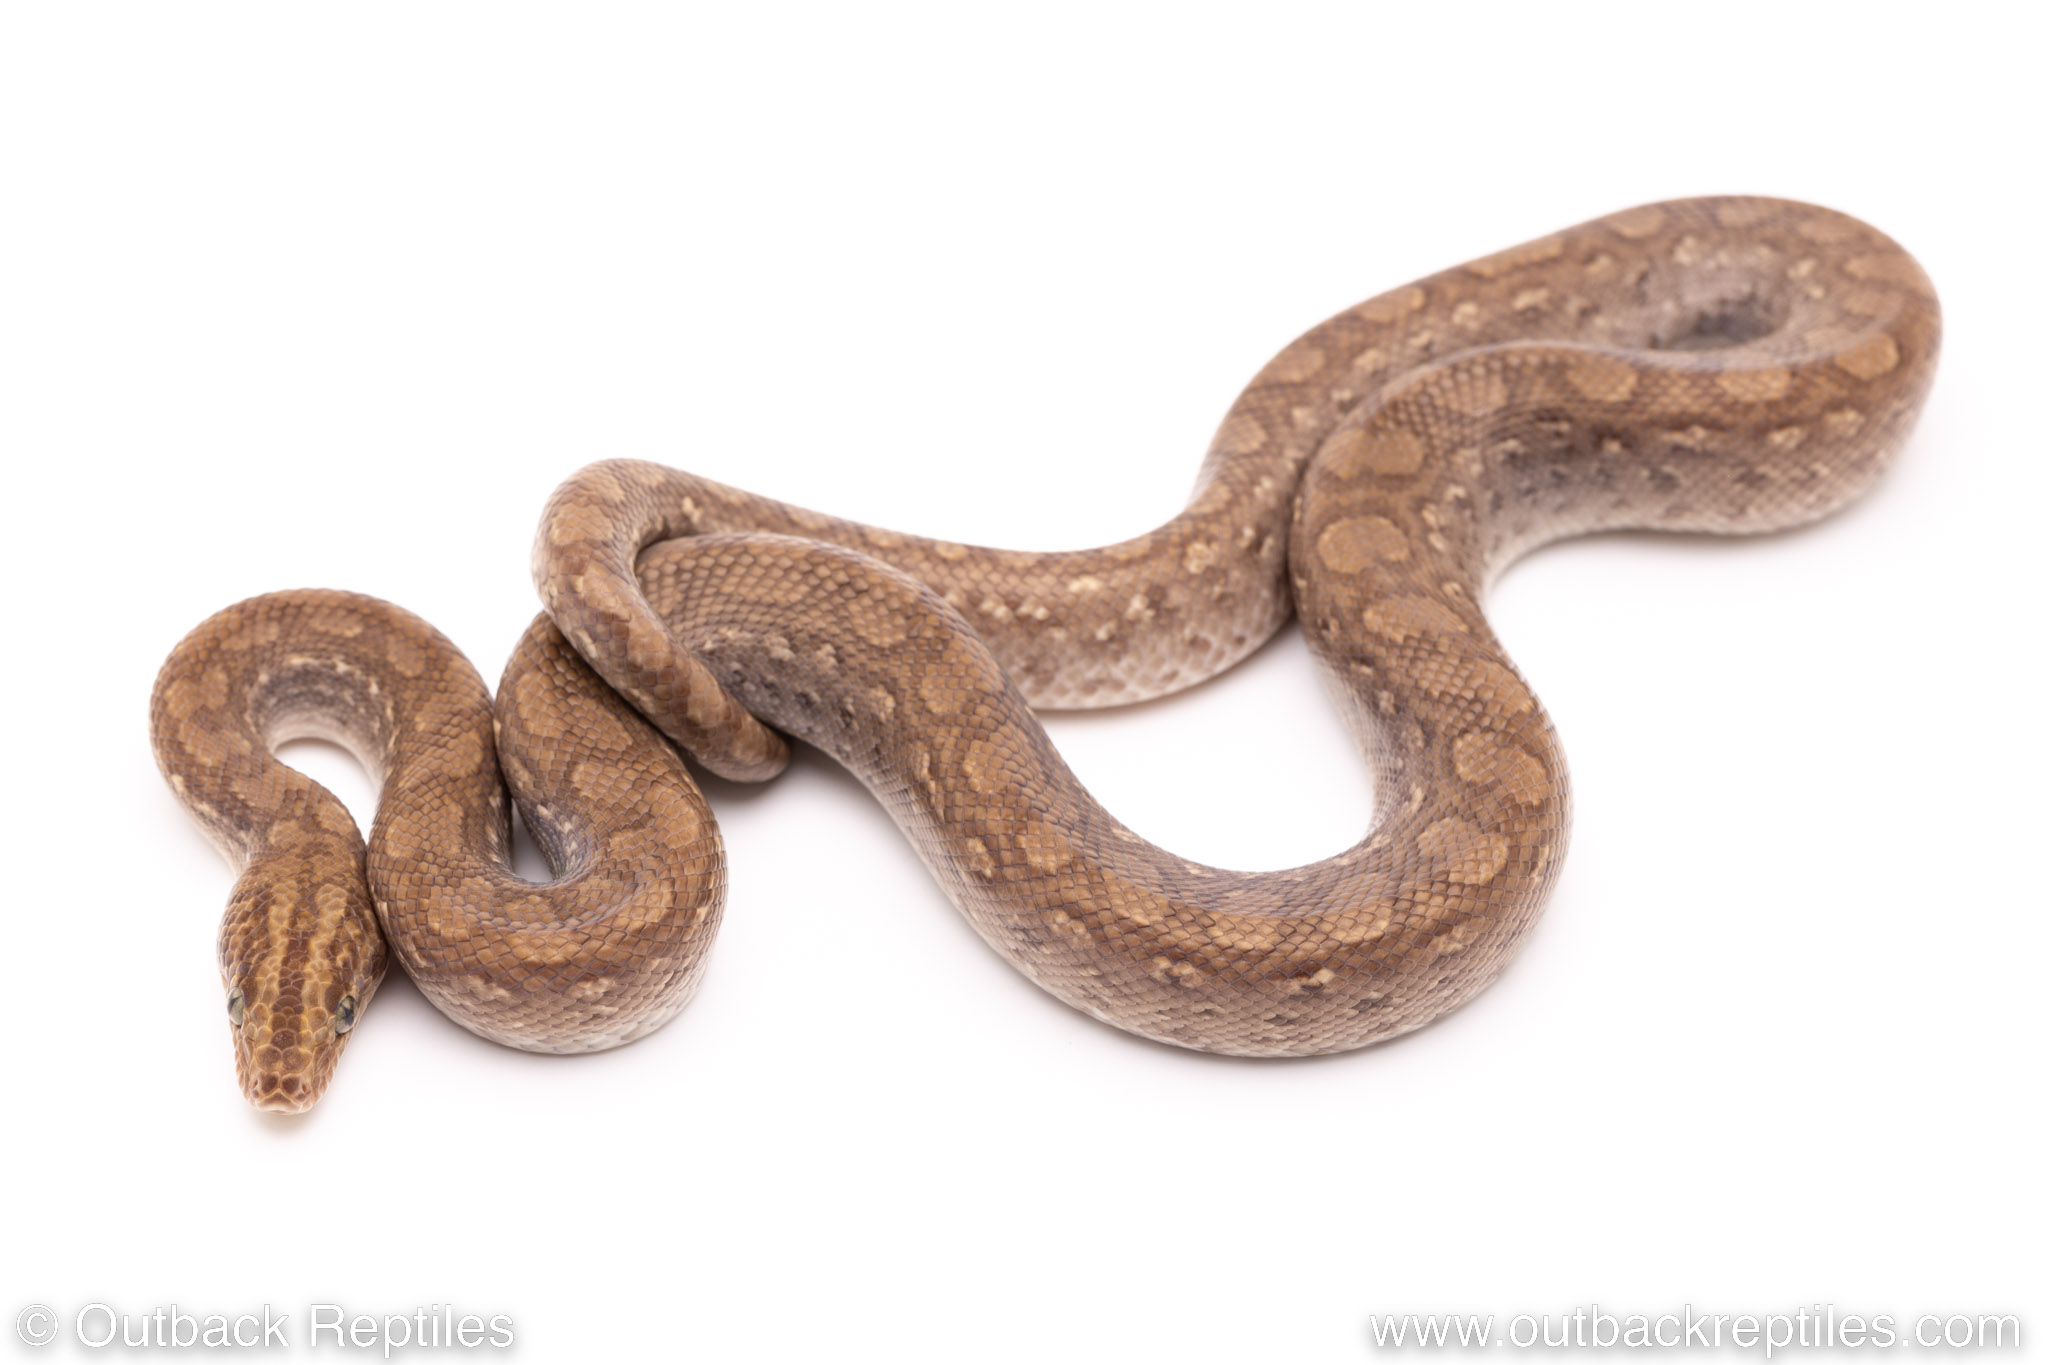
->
221, 863, 385, 1113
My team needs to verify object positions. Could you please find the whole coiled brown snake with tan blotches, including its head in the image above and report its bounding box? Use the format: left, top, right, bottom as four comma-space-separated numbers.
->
152, 199, 1939, 1109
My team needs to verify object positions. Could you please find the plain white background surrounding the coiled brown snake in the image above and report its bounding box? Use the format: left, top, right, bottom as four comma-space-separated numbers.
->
0, 4, 2048, 1365
